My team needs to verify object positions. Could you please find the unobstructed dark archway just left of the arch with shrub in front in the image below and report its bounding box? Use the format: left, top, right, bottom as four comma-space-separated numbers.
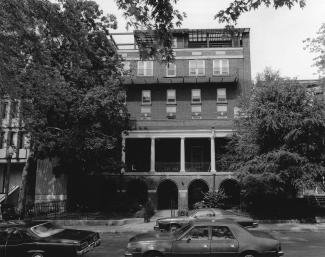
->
157, 180, 178, 210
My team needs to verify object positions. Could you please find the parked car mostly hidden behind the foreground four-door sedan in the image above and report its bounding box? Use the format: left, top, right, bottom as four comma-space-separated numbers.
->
154, 208, 258, 231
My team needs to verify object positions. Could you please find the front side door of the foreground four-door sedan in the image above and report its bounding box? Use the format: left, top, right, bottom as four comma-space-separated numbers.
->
171, 226, 210, 257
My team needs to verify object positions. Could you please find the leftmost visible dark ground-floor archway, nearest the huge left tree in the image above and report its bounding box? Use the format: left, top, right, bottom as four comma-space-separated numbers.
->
126, 179, 148, 206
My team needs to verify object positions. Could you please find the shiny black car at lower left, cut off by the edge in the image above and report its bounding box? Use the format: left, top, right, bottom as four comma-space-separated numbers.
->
0, 218, 100, 257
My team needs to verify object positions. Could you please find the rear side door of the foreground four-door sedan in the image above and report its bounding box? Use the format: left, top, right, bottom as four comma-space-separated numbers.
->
210, 226, 239, 257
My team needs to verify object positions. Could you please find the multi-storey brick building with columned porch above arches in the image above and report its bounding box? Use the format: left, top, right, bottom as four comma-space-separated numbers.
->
108, 28, 251, 209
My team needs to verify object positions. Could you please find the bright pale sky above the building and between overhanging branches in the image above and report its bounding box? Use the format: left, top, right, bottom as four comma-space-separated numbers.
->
95, 0, 325, 79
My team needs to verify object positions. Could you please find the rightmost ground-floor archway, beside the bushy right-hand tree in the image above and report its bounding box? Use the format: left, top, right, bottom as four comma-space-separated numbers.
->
219, 179, 240, 207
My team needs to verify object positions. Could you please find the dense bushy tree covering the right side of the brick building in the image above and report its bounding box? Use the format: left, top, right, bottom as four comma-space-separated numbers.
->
224, 68, 325, 210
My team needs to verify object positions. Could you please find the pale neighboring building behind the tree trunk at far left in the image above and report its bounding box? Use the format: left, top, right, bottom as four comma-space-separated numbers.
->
0, 98, 67, 205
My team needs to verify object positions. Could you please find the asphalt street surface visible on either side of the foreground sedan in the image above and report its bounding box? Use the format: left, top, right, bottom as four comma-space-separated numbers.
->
87, 231, 325, 257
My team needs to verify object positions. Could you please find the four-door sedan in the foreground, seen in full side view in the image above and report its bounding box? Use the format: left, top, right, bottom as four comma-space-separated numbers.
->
125, 220, 284, 257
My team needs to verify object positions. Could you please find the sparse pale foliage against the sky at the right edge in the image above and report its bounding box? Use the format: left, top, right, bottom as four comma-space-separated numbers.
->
304, 23, 325, 75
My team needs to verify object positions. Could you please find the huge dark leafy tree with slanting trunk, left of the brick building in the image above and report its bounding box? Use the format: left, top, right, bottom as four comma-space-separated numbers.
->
0, 0, 128, 214
